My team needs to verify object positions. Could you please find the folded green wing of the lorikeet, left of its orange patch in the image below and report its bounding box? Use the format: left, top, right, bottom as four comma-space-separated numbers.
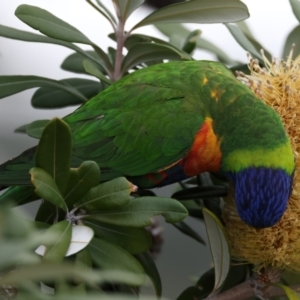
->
65, 64, 203, 176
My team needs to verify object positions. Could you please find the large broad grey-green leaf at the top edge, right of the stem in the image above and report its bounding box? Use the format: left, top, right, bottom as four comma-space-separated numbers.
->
132, 0, 249, 30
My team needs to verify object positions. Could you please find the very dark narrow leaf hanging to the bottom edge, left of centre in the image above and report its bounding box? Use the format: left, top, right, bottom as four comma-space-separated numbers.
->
135, 252, 162, 299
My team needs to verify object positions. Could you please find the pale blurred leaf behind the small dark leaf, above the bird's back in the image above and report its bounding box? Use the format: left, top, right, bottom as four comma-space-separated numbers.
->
155, 23, 233, 63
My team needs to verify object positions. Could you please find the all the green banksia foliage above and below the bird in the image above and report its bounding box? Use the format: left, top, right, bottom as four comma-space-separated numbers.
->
0, 0, 300, 300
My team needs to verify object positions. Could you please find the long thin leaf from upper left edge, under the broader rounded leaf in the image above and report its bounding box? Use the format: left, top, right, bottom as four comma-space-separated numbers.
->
0, 25, 108, 67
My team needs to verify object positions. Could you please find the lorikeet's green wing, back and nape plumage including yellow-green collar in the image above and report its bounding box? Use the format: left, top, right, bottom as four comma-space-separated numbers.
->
66, 61, 294, 176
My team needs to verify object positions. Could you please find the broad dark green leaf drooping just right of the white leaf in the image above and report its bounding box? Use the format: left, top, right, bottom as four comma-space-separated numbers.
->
88, 238, 145, 285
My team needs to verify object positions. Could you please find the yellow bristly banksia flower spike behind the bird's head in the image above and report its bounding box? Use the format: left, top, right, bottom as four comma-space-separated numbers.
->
223, 46, 300, 272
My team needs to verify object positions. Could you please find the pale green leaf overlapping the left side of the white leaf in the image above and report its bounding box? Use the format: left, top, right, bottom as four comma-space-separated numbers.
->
35, 220, 72, 262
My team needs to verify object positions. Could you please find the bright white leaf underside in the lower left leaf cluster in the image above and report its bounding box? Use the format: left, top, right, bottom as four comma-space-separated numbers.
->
65, 225, 94, 256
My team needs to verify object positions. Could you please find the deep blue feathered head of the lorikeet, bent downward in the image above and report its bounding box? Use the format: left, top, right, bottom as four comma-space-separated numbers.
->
228, 167, 293, 228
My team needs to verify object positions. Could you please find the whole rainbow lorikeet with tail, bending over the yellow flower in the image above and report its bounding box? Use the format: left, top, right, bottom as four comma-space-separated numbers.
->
0, 61, 295, 228
